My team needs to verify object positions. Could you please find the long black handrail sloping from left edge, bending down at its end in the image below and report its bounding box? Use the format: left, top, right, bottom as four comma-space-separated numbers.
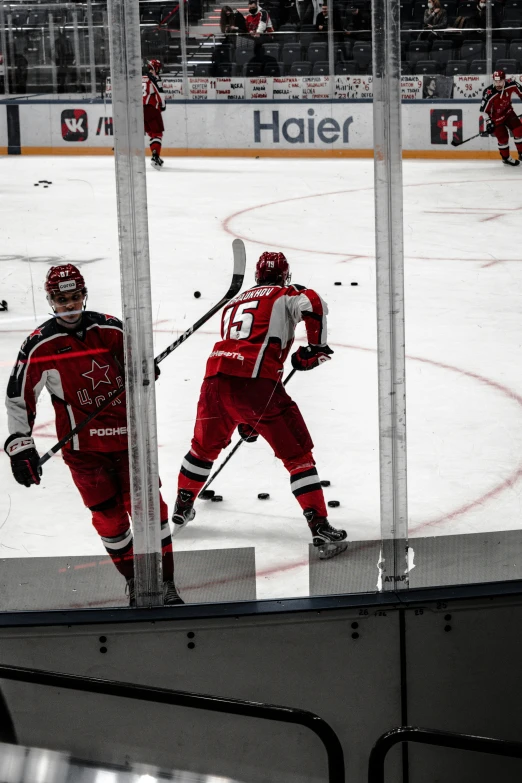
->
0, 665, 345, 783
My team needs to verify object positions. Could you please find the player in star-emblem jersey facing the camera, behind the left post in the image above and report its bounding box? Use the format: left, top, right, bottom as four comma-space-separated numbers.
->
4, 264, 183, 606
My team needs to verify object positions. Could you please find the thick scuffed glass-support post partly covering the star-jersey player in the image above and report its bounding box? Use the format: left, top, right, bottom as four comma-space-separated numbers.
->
108, 0, 163, 606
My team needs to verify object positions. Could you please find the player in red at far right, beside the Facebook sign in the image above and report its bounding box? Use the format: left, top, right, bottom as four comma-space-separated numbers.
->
480, 70, 522, 166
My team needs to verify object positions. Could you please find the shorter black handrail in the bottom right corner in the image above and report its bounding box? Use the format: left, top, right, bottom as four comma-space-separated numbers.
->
368, 726, 522, 783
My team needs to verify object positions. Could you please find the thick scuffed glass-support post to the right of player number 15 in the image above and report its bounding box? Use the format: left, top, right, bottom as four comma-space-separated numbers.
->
372, 0, 408, 590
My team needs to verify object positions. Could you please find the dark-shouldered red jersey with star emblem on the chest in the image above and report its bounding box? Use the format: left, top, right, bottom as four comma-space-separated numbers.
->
6, 312, 127, 451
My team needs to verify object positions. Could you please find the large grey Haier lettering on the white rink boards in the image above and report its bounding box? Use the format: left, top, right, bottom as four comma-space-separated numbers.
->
254, 109, 353, 144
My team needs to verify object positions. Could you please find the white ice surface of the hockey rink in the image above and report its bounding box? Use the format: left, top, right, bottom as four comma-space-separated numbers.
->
0, 156, 522, 608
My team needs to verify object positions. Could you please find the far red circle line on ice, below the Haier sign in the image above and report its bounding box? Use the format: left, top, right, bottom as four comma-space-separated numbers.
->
222, 177, 520, 266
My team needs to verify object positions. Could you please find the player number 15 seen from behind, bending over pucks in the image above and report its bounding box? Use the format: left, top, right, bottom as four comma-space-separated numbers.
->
172, 252, 347, 559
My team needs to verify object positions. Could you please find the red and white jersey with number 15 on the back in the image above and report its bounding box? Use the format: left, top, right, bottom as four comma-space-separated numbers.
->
205, 284, 328, 380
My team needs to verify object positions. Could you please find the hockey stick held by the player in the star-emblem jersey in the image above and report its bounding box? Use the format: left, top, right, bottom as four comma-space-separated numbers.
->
38, 239, 246, 466
